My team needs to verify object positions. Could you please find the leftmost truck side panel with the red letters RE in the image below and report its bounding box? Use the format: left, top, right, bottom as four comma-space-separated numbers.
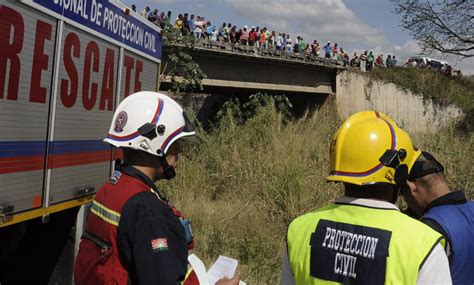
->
0, 0, 57, 212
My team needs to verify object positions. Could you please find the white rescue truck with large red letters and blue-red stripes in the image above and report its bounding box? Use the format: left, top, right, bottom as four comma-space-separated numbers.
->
0, 0, 162, 282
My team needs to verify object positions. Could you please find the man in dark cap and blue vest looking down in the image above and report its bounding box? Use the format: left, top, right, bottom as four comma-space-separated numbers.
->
402, 151, 474, 284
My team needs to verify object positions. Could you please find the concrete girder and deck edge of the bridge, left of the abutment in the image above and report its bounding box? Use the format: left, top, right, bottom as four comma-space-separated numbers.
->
162, 41, 342, 95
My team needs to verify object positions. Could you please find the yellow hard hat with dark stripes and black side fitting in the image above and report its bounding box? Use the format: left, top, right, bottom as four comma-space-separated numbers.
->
327, 111, 421, 185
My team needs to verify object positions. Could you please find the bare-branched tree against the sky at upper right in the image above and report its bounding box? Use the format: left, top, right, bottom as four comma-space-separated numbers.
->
391, 0, 474, 58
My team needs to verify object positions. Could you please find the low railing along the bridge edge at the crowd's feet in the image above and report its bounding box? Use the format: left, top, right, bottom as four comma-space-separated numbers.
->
191, 39, 342, 67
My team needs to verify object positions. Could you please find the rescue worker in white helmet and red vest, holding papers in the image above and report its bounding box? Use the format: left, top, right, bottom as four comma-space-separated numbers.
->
74, 92, 239, 285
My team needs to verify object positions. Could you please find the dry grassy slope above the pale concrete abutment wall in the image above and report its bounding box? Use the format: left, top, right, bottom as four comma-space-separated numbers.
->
373, 67, 474, 132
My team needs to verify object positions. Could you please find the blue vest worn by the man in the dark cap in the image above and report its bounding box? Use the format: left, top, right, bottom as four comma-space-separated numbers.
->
423, 201, 474, 284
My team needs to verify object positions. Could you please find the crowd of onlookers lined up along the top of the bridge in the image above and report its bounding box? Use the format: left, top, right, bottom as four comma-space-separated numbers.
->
132, 5, 460, 76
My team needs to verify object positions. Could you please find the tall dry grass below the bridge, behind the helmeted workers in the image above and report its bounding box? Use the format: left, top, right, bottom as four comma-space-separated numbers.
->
160, 106, 474, 284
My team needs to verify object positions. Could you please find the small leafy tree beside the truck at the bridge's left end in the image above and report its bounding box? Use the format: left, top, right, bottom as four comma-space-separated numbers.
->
160, 25, 206, 92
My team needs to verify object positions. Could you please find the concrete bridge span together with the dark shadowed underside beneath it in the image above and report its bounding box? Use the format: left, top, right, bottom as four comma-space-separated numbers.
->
160, 41, 344, 122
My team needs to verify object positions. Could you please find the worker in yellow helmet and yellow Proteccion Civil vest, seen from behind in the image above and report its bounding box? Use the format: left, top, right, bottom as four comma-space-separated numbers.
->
280, 111, 451, 284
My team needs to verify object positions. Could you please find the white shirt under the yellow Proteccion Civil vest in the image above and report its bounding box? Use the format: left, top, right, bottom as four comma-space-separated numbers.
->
280, 196, 452, 285
